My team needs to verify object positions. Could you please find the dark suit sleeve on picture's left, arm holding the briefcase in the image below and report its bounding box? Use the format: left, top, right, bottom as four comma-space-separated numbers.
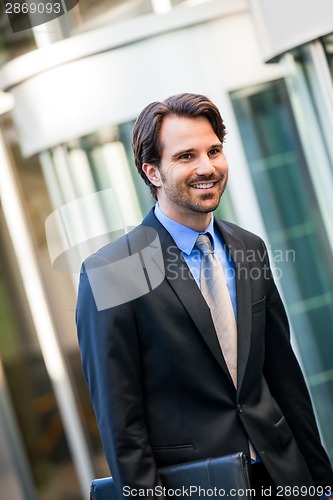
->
76, 256, 161, 498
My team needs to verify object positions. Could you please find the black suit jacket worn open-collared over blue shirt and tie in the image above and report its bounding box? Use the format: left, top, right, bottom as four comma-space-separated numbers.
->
77, 211, 333, 494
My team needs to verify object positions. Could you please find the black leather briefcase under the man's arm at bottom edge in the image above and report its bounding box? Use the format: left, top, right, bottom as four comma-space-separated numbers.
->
90, 452, 251, 500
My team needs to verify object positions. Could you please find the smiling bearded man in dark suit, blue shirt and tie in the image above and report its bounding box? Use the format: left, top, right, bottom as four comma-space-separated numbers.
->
77, 94, 333, 498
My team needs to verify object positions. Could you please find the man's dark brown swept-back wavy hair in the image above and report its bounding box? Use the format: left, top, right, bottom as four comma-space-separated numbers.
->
132, 93, 226, 199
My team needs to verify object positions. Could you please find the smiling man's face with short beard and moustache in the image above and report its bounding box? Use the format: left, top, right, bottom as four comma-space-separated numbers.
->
144, 116, 228, 230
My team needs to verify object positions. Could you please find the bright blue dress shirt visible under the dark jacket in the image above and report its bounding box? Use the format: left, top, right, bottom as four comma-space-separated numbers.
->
155, 203, 237, 318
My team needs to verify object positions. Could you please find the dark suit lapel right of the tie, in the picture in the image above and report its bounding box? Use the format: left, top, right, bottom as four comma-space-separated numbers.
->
216, 220, 252, 391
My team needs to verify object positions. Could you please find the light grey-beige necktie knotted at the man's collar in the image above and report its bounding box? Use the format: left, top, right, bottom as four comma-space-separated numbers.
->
196, 234, 237, 387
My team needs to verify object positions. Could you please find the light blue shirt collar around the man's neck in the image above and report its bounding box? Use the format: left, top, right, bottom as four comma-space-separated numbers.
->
155, 203, 215, 255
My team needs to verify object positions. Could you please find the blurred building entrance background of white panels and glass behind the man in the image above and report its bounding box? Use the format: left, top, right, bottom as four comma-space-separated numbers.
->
0, 0, 333, 500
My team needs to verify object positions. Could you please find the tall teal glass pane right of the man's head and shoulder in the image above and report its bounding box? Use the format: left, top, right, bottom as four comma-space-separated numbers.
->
231, 80, 333, 456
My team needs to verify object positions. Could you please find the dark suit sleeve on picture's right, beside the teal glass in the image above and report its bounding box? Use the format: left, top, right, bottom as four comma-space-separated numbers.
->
264, 241, 333, 487
